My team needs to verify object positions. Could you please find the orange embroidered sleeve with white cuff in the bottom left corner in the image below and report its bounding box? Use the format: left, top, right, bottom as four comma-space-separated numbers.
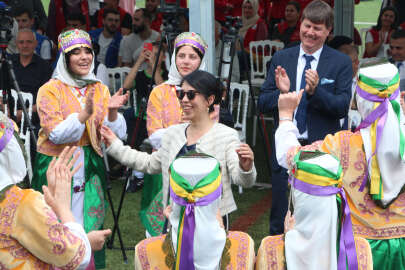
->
10, 191, 91, 269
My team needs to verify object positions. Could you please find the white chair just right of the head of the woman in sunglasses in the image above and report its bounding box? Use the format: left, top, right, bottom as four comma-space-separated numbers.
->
229, 83, 249, 194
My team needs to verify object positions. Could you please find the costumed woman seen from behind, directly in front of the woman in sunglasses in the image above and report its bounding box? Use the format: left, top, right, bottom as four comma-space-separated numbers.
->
135, 153, 255, 270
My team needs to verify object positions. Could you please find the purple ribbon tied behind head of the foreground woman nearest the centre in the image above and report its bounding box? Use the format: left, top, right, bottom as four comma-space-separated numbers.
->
170, 183, 222, 270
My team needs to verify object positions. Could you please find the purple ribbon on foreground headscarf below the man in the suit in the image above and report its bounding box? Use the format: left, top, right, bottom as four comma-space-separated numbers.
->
288, 177, 358, 270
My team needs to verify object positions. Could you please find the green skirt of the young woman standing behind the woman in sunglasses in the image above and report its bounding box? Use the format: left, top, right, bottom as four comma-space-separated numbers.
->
139, 174, 165, 236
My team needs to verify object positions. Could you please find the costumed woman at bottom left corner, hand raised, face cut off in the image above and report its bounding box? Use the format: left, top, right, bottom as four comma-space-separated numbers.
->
0, 112, 91, 270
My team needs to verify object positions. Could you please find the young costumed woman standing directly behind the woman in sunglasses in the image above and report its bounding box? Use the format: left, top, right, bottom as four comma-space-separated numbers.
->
140, 32, 216, 236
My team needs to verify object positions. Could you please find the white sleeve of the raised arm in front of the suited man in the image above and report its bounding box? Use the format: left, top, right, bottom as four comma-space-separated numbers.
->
274, 121, 300, 169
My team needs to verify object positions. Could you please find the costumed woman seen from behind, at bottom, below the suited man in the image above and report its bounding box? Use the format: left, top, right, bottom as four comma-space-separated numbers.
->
256, 151, 373, 270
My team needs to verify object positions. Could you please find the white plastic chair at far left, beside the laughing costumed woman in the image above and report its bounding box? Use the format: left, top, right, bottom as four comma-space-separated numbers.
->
6, 89, 33, 183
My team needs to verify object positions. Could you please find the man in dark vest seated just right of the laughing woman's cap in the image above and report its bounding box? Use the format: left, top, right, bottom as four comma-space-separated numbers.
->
89, 9, 122, 68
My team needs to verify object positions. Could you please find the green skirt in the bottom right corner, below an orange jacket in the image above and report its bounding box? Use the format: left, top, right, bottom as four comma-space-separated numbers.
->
367, 238, 405, 270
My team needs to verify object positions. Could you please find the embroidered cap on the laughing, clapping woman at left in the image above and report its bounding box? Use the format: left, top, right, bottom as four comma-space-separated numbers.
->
58, 29, 92, 53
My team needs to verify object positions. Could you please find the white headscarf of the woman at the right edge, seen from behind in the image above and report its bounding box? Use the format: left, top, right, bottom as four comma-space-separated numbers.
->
356, 64, 405, 205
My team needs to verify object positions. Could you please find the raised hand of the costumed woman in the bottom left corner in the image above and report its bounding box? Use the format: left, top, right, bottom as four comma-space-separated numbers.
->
42, 147, 82, 223
